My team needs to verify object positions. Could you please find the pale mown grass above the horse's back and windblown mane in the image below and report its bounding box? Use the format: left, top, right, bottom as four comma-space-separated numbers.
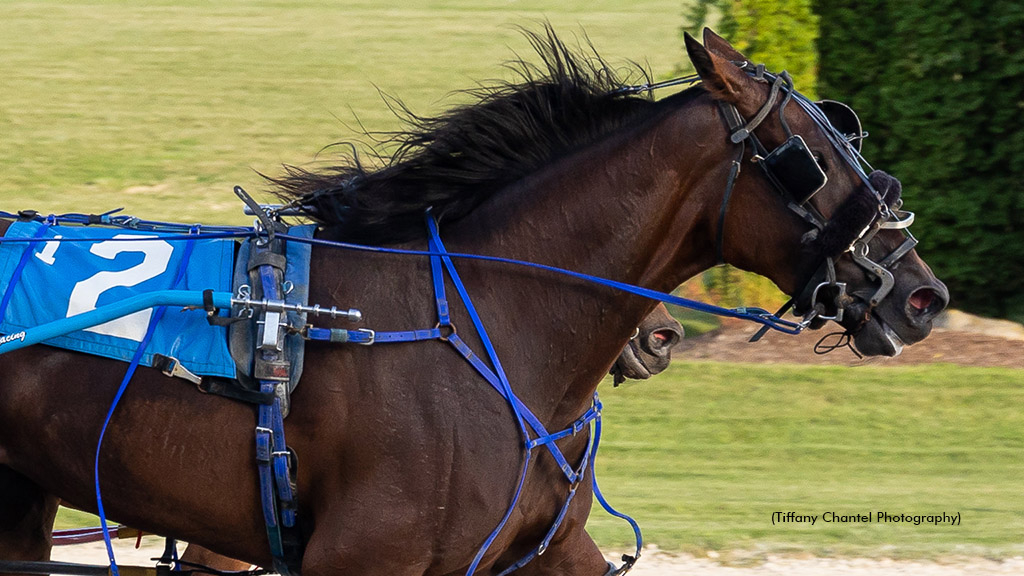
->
0, 0, 684, 222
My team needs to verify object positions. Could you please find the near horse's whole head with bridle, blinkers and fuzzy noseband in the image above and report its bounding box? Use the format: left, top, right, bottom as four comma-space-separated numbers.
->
686, 31, 949, 356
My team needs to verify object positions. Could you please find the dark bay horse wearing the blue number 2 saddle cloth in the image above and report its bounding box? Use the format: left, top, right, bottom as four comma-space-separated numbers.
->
0, 28, 947, 576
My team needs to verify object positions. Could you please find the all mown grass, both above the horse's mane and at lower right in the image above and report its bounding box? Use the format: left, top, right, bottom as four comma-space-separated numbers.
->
14, 0, 1024, 557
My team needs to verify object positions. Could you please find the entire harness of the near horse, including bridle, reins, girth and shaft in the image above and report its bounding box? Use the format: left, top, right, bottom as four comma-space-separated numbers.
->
0, 63, 916, 576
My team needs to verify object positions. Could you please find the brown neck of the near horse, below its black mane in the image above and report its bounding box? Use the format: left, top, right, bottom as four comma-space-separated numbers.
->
441, 94, 727, 422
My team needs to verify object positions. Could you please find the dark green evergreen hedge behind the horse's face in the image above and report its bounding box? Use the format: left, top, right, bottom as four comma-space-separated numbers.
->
814, 0, 1024, 321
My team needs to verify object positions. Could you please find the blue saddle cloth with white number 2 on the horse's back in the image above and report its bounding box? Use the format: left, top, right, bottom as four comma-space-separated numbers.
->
0, 221, 236, 378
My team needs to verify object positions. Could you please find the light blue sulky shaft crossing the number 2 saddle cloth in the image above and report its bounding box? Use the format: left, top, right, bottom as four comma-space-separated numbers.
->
0, 290, 231, 354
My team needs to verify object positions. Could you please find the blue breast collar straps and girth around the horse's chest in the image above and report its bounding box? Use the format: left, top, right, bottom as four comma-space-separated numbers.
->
234, 212, 642, 576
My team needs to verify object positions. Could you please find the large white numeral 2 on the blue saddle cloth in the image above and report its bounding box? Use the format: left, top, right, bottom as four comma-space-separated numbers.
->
67, 234, 174, 342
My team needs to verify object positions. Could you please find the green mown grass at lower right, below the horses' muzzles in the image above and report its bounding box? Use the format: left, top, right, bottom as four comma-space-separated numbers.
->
590, 362, 1024, 558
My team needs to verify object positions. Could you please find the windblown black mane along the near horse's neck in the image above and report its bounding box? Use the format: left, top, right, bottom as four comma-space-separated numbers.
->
268, 25, 653, 244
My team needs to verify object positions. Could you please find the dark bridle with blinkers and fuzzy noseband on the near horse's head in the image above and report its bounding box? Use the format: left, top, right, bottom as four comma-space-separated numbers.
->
716, 61, 918, 340
